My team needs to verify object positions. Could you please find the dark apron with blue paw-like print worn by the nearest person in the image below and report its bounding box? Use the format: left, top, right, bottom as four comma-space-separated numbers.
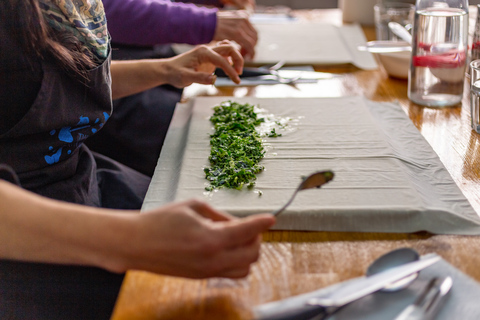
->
0, 51, 149, 209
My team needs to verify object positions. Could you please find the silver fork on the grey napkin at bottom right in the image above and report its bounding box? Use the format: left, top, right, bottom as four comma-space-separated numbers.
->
395, 277, 453, 320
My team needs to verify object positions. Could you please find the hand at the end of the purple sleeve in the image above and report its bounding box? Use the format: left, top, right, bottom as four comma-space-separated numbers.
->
213, 11, 258, 58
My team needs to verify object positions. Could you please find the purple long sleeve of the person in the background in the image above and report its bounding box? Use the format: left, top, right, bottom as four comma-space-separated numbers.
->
103, 0, 217, 46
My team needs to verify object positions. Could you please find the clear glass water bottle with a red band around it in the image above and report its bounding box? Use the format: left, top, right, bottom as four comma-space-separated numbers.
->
408, 0, 468, 108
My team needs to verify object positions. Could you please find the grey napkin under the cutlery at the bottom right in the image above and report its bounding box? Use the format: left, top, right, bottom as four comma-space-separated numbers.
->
254, 260, 480, 320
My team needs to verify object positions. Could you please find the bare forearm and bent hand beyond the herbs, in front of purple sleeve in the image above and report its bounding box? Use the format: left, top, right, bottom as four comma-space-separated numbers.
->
111, 41, 243, 99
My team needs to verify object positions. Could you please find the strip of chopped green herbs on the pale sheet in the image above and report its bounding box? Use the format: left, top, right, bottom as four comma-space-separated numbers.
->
204, 101, 279, 191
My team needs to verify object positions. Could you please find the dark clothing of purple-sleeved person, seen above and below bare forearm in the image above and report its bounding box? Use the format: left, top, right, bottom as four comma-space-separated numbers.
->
87, 43, 183, 177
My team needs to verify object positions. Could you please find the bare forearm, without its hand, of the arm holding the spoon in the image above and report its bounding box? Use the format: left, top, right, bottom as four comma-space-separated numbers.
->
0, 181, 134, 271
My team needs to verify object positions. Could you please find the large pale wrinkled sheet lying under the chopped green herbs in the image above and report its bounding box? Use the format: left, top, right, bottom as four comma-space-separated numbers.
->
143, 97, 480, 235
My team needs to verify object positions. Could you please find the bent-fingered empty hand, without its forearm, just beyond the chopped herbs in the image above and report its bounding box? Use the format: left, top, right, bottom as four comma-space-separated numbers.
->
165, 40, 243, 88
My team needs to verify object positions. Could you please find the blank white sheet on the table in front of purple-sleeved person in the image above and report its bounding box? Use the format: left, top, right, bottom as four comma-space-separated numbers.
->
173, 22, 378, 70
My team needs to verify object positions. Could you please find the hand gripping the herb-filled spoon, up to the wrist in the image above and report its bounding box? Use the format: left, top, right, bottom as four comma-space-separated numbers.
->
122, 200, 275, 278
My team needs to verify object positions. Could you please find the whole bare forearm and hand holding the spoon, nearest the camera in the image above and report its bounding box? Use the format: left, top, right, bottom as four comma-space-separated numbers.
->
0, 180, 275, 278
